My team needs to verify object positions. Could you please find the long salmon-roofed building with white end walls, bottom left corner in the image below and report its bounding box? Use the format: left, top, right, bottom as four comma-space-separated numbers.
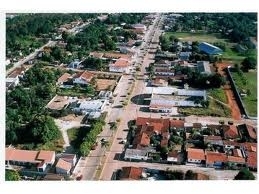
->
5, 147, 55, 172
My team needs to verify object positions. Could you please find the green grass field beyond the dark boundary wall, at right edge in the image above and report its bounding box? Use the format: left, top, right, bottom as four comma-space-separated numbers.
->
231, 72, 257, 116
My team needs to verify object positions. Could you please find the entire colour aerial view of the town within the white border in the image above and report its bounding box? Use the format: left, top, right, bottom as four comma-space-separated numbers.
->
5, 12, 257, 181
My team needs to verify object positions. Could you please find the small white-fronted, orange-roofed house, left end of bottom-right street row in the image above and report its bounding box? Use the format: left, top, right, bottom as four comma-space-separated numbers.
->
187, 148, 205, 164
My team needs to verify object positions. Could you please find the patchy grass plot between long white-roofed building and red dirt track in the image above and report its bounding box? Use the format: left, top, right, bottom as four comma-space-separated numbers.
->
178, 99, 231, 117
